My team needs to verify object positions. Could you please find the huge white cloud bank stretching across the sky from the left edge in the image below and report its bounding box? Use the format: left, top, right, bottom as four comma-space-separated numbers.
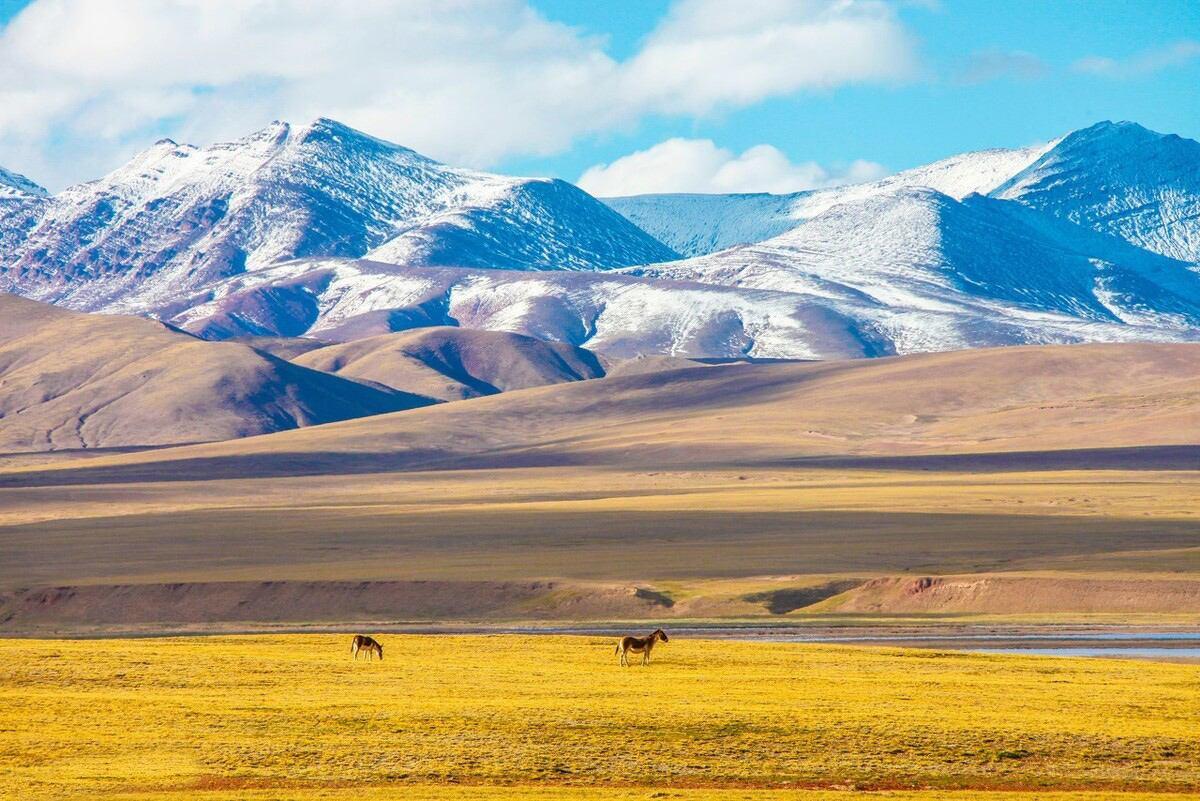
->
0, 0, 914, 185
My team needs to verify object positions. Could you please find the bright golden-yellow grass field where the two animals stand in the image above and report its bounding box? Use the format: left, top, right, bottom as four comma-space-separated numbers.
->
0, 634, 1200, 801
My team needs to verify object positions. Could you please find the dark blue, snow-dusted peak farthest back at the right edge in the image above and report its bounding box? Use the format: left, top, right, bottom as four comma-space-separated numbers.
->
992, 122, 1200, 261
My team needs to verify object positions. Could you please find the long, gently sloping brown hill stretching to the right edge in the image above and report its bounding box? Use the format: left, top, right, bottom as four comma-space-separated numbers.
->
42, 344, 1200, 475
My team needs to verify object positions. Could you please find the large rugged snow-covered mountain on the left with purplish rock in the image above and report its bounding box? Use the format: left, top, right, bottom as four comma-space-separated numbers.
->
0, 119, 676, 312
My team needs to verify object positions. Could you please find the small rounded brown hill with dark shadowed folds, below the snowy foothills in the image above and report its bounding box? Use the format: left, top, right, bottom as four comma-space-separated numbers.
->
293, 327, 605, 401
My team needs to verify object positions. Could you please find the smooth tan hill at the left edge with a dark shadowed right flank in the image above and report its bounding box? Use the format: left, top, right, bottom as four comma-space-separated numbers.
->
0, 295, 433, 451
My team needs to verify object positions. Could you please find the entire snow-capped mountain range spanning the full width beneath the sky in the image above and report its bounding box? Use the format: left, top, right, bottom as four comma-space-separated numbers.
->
0, 120, 1200, 359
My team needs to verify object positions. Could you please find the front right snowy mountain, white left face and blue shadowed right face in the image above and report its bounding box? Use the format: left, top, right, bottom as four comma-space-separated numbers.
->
629, 188, 1200, 350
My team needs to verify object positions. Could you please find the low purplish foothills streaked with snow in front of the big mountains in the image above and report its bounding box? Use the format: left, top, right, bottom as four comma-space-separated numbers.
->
170, 259, 902, 359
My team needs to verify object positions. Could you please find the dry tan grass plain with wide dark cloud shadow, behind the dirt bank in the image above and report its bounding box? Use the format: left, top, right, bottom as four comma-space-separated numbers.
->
0, 462, 1200, 588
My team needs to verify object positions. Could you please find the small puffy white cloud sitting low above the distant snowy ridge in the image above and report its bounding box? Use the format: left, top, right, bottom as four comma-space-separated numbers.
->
577, 139, 887, 197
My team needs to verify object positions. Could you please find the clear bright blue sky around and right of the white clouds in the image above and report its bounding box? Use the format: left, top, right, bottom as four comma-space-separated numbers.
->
509, 0, 1200, 182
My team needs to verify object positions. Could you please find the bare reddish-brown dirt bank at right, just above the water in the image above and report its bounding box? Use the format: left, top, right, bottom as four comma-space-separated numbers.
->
814, 576, 1200, 614
